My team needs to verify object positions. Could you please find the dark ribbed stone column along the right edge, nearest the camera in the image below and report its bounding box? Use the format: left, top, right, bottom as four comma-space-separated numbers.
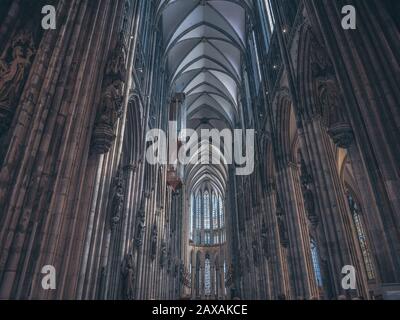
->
304, 0, 400, 283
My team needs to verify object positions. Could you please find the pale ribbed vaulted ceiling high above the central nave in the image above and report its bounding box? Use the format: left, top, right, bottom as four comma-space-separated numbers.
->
159, 0, 251, 192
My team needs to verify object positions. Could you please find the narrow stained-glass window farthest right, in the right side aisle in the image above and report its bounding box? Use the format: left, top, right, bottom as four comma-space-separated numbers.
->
347, 193, 375, 280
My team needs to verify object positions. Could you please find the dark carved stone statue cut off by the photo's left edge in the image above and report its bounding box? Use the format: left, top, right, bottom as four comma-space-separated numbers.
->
0, 30, 35, 136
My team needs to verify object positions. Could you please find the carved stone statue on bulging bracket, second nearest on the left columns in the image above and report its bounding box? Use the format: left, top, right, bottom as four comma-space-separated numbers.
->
92, 34, 127, 154
